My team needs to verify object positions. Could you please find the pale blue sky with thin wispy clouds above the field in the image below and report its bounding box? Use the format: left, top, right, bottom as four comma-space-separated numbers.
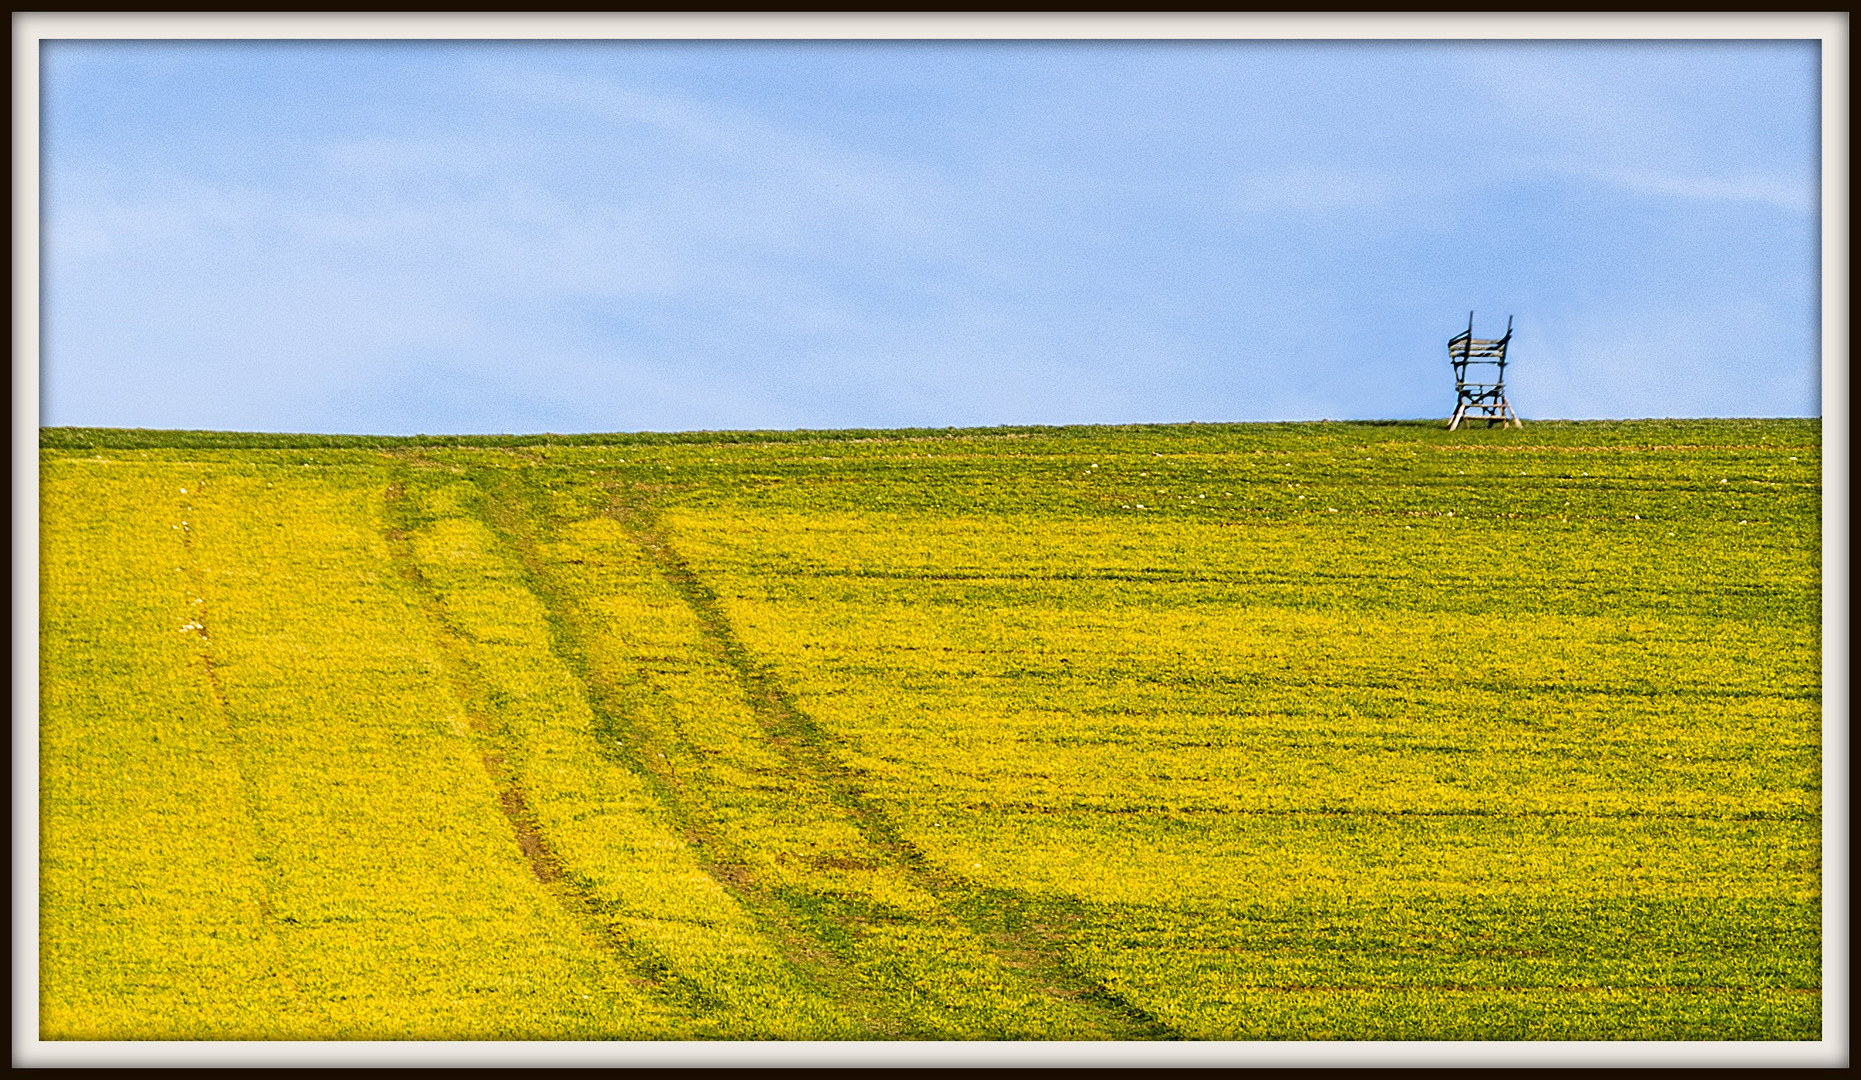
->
41, 41, 1822, 434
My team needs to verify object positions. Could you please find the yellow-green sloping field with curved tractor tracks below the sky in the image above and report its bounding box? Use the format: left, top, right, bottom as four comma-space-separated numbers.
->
39, 421, 1822, 1039
